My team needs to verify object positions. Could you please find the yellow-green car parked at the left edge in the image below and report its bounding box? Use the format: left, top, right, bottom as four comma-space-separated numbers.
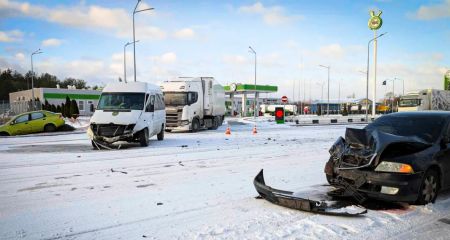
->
0, 111, 65, 136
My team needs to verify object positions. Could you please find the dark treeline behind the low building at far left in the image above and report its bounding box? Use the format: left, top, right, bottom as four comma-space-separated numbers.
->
0, 69, 97, 101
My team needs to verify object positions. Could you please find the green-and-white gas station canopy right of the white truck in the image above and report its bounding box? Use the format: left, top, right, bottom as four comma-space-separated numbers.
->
224, 83, 278, 117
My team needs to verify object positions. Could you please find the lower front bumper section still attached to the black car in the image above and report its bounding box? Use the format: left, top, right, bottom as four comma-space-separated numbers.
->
337, 169, 423, 203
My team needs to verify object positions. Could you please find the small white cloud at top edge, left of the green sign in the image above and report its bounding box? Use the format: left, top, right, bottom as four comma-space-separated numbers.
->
239, 2, 302, 26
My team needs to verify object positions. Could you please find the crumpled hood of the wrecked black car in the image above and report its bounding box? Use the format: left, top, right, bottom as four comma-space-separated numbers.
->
330, 128, 433, 167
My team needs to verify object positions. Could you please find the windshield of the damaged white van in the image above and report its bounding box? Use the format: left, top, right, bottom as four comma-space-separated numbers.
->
97, 92, 145, 110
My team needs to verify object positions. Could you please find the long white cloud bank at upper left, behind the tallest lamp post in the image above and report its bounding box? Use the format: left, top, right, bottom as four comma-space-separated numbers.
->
0, 0, 166, 39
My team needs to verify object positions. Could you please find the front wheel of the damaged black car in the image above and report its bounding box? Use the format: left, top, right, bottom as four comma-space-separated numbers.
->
417, 169, 439, 205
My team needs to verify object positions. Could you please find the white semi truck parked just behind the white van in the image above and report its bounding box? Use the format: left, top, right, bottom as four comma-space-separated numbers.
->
161, 77, 225, 132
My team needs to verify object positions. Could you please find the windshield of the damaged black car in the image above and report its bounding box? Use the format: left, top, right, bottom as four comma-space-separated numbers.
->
366, 116, 445, 143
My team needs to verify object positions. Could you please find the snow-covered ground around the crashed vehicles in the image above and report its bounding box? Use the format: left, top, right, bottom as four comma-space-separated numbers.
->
0, 119, 450, 239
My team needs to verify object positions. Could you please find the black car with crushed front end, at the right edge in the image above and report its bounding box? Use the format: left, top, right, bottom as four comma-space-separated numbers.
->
325, 111, 450, 204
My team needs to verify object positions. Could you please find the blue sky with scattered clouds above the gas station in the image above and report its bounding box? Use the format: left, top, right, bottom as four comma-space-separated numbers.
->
0, 0, 450, 99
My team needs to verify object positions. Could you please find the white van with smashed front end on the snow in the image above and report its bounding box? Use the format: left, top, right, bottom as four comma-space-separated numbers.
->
88, 82, 166, 148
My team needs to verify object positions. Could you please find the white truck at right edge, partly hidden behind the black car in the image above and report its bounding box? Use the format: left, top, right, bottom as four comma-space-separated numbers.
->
398, 89, 450, 112
